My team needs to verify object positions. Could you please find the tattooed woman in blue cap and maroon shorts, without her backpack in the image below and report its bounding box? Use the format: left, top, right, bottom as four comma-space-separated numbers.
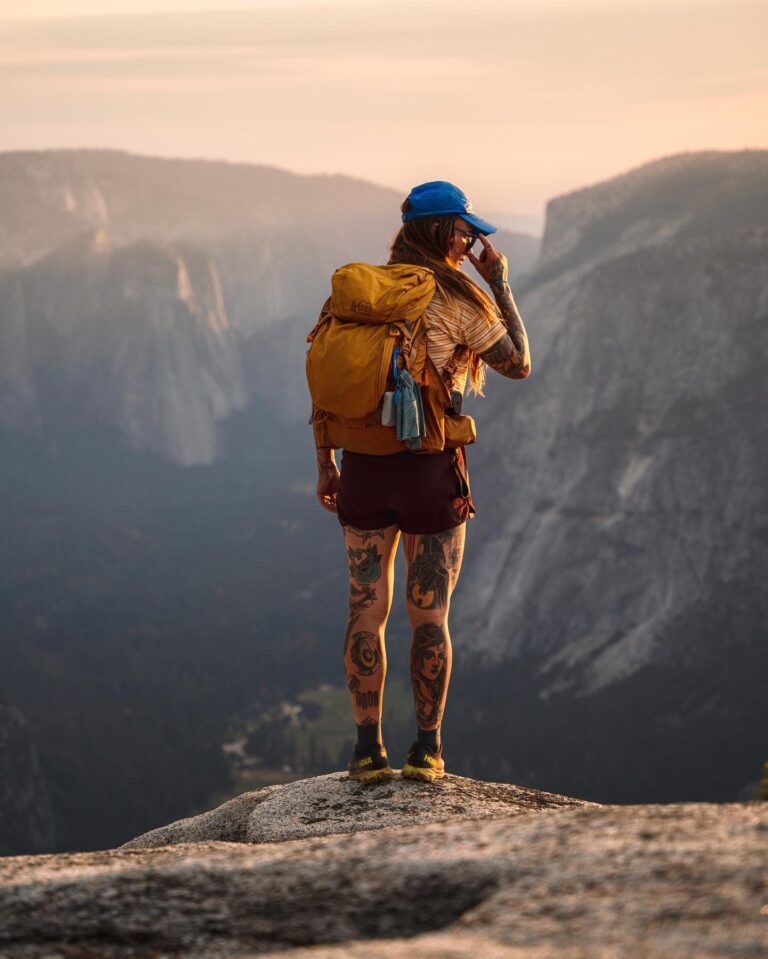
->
317, 180, 530, 782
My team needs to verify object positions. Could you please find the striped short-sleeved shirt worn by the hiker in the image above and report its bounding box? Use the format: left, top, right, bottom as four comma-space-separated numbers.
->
426, 288, 507, 393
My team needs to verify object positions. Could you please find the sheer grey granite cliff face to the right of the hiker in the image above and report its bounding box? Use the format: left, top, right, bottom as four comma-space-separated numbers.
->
460, 229, 768, 692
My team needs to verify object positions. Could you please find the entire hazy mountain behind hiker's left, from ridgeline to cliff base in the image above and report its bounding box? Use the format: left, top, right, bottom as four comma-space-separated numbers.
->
0, 150, 538, 465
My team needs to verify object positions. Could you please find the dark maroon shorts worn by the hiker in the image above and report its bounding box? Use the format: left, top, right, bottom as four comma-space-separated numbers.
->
336, 447, 475, 533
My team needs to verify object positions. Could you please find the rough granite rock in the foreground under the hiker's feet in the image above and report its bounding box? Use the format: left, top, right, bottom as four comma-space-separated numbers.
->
0, 774, 768, 959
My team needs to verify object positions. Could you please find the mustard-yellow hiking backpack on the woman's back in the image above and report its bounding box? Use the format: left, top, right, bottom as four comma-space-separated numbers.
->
306, 263, 475, 455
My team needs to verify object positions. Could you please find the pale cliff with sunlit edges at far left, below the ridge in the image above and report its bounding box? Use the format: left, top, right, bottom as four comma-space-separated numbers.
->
0, 230, 246, 463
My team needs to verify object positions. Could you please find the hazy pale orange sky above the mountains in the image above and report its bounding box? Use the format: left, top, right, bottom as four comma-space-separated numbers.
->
0, 0, 768, 229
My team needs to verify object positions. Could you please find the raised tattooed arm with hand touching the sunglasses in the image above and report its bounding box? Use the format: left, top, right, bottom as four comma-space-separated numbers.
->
467, 234, 531, 380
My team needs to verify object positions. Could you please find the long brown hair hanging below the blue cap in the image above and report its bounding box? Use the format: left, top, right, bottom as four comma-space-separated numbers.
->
389, 200, 498, 396
